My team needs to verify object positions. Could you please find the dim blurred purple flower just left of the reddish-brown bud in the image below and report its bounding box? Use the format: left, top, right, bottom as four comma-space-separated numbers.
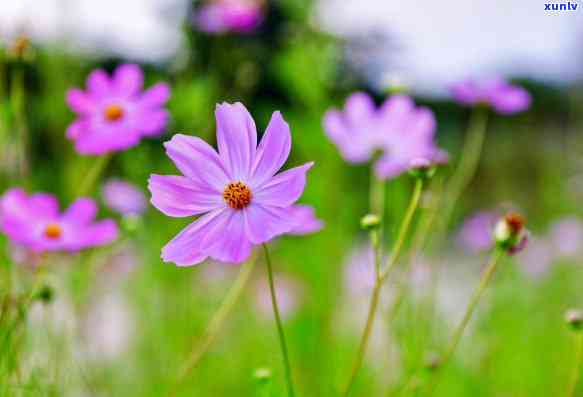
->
457, 211, 500, 252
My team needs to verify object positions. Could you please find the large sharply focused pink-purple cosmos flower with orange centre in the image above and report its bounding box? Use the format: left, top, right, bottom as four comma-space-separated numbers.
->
148, 103, 313, 266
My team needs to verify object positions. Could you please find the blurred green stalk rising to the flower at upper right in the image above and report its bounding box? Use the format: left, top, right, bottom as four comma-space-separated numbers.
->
436, 106, 488, 246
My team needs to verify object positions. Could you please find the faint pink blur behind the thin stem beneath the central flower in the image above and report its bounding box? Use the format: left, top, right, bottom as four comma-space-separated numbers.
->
255, 274, 303, 320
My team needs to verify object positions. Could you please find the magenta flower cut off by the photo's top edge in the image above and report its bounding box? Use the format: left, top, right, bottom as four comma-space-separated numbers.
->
194, 0, 264, 33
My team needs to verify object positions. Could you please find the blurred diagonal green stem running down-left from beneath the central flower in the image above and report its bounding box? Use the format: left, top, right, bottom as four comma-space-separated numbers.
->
168, 259, 255, 397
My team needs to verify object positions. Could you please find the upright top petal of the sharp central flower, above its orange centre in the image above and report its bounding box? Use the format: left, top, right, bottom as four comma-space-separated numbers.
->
215, 102, 257, 180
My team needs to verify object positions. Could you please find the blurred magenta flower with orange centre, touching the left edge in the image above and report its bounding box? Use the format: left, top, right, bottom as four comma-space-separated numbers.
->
0, 189, 117, 252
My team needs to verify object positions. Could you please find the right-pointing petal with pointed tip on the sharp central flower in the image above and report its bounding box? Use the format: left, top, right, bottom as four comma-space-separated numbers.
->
253, 162, 314, 208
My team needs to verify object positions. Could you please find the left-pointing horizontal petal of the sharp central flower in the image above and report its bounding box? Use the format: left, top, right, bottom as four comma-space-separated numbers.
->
148, 174, 225, 217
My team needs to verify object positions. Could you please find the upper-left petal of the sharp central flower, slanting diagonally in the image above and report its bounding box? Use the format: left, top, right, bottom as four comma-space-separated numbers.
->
164, 134, 231, 193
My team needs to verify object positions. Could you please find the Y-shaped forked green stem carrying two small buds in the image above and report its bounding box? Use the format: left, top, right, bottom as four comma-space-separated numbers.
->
343, 179, 423, 396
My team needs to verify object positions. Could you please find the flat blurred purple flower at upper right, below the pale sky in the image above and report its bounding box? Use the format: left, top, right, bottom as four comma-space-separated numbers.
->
450, 77, 531, 114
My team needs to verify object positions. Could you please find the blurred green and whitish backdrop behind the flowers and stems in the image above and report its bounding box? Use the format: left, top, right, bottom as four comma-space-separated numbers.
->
0, 0, 583, 397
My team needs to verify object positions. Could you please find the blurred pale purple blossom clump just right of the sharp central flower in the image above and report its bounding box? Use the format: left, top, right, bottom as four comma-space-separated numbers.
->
324, 92, 447, 179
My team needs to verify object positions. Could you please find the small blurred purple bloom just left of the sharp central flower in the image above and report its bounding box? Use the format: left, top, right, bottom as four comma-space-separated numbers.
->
102, 179, 147, 215
